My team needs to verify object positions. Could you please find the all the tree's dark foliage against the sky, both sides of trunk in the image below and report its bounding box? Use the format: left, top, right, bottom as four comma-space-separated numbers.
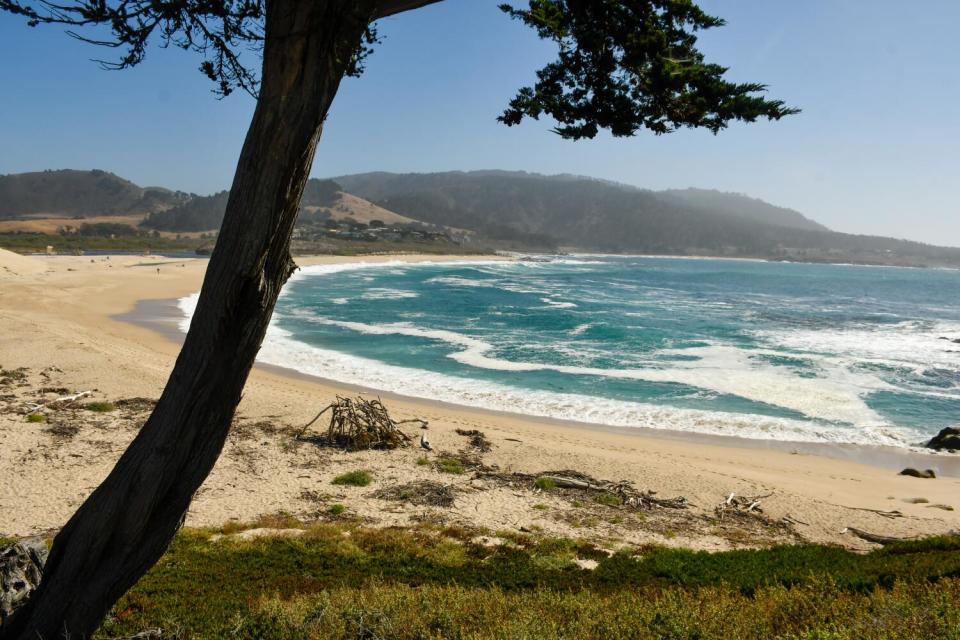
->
0, 0, 797, 134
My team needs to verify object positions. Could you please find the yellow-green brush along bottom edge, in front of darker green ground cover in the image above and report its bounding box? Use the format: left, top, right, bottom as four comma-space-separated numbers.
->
210, 581, 960, 640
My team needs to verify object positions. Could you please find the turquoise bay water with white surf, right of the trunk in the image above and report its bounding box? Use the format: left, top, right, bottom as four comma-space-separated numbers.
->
182, 256, 960, 446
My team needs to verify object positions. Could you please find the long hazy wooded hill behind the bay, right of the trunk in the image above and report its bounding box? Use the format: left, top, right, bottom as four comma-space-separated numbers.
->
335, 171, 960, 266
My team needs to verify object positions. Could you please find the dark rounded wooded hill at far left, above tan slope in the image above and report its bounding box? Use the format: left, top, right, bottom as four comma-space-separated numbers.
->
0, 169, 188, 219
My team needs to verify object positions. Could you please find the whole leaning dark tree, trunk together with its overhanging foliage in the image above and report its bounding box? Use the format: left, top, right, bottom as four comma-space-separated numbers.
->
0, 0, 793, 640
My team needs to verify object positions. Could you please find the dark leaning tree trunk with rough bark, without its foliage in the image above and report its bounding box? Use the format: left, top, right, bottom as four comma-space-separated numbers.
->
0, 0, 375, 640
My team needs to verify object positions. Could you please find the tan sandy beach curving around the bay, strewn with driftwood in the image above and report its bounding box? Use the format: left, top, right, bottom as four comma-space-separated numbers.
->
0, 251, 960, 549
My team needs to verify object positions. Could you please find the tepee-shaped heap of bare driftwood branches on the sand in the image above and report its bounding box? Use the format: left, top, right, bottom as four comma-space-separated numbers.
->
297, 396, 427, 451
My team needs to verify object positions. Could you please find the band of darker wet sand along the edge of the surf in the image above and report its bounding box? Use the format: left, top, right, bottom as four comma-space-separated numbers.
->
115, 298, 960, 477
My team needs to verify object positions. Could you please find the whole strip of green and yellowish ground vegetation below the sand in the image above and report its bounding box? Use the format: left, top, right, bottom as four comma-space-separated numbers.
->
86, 522, 960, 640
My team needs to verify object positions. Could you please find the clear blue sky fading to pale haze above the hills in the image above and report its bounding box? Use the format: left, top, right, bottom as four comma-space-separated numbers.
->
0, 0, 960, 246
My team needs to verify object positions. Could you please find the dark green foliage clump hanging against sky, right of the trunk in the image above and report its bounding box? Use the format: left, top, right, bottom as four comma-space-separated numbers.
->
499, 0, 797, 140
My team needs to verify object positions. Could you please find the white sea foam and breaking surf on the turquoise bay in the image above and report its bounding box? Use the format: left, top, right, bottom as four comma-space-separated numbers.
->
174, 259, 960, 446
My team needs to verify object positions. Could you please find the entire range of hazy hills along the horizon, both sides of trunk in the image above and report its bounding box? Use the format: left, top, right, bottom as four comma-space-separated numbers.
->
0, 170, 960, 267
